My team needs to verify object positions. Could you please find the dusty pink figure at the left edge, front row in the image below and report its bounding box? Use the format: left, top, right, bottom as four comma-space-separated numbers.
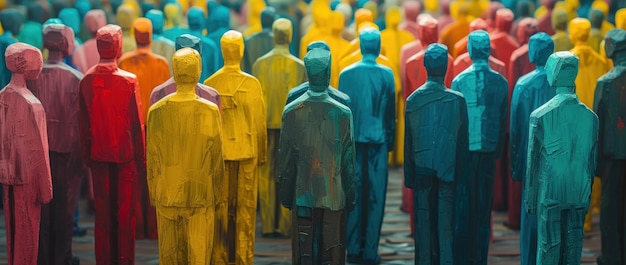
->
0, 43, 51, 265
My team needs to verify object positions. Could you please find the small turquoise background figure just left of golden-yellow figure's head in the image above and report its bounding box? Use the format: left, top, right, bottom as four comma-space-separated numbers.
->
187, 7, 221, 81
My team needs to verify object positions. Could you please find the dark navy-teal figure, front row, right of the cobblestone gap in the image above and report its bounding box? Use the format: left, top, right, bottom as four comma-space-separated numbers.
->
404, 44, 468, 264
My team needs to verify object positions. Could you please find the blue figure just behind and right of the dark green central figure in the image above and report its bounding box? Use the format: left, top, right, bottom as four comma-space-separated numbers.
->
339, 28, 396, 264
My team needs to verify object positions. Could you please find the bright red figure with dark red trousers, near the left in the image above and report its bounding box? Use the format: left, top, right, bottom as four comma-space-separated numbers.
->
79, 24, 145, 265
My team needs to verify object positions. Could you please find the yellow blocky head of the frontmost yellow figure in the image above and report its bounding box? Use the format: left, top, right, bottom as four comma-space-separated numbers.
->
172, 48, 202, 85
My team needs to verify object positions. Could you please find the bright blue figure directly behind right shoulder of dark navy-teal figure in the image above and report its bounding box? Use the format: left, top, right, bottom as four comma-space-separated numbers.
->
452, 30, 509, 264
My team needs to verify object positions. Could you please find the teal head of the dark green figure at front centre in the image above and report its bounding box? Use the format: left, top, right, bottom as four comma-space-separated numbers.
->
304, 49, 331, 92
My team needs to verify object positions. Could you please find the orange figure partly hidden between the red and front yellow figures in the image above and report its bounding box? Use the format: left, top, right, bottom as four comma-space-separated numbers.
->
118, 18, 170, 239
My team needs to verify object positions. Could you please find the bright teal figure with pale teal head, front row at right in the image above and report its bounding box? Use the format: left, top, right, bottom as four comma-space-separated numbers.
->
524, 52, 598, 265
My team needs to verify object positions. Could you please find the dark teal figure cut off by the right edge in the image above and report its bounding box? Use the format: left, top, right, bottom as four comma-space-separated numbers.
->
593, 29, 626, 265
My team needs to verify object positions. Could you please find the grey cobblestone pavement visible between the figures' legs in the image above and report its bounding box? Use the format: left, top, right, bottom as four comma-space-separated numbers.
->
0, 168, 600, 265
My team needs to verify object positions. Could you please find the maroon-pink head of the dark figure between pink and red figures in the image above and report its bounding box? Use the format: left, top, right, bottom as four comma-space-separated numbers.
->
43, 24, 74, 58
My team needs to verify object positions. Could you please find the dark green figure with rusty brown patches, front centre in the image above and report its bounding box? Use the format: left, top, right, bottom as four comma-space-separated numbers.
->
278, 48, 356, 264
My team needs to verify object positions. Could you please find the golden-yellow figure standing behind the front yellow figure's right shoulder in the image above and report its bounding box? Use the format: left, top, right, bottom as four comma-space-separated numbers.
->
204, 30, 267, 265
